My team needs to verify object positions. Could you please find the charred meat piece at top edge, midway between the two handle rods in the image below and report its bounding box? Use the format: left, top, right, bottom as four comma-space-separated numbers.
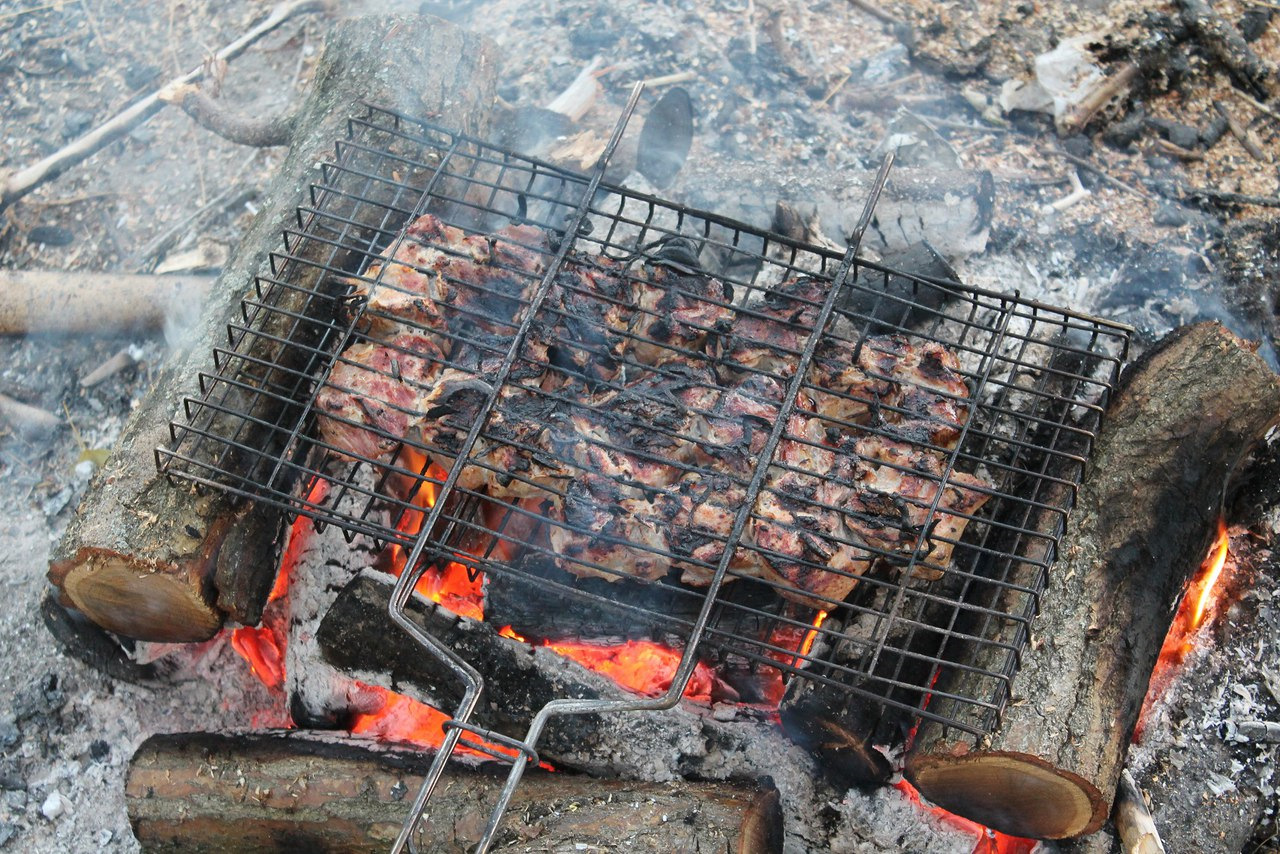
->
628, 264, 733, 365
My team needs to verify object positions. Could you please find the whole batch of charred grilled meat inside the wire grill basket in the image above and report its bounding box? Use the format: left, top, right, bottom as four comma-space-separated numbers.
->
317, 215, 989, 609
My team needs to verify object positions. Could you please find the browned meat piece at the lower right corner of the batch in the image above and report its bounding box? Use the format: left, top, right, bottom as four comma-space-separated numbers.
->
840, 435, 991, 580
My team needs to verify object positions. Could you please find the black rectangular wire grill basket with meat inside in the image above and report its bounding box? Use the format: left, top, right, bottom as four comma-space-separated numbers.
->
157, 106, 1128, 732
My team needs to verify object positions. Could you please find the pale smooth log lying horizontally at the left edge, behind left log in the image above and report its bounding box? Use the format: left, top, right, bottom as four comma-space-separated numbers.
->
0, 270, 214, 335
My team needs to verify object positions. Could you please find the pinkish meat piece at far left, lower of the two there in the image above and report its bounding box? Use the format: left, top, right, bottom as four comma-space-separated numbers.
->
316, 334, 443, 460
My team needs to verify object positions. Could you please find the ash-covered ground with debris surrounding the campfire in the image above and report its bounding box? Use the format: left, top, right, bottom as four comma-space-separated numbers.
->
0, 0, 1280, 851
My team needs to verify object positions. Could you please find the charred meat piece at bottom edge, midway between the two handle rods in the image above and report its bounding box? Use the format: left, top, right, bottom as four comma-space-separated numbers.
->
548, 474, 671, 581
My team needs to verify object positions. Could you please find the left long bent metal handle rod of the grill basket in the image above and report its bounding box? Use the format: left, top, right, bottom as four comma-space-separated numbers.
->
388, 82, 650, 854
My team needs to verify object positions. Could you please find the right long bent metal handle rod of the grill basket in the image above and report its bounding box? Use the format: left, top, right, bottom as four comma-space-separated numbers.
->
450, 152, 893, 854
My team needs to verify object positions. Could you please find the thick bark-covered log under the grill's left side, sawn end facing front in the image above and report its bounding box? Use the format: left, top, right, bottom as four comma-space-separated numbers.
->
50, 15, 494, 641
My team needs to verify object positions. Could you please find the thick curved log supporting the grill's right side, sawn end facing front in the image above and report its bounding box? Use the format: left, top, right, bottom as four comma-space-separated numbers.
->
906, 324, 1280, 839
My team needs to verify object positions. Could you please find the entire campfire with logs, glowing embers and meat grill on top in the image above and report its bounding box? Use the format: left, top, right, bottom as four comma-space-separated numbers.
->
12, 6, 1280, 853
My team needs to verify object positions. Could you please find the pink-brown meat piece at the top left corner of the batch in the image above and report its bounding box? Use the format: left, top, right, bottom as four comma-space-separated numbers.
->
352, 214, 547, 348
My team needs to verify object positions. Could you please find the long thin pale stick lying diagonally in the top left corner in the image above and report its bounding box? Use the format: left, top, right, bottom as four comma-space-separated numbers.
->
0, 0, 324, 210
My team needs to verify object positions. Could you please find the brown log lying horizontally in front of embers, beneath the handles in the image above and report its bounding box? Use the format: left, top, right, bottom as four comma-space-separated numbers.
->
124, 732, 782, 854
